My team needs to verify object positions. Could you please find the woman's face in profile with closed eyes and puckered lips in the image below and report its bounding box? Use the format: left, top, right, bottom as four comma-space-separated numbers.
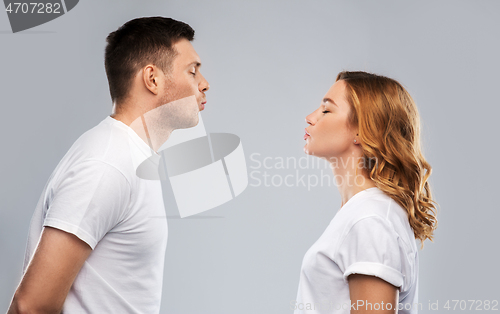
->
304, 80, 359, 159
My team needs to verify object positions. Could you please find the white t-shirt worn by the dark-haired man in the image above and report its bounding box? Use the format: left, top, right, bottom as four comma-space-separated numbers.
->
24, 116, 168, 314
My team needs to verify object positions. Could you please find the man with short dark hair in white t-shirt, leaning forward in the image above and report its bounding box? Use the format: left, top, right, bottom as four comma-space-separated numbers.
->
8, 17, 209, 313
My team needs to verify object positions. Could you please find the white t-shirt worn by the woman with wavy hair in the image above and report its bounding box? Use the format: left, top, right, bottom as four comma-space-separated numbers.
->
291, 187, 419, 314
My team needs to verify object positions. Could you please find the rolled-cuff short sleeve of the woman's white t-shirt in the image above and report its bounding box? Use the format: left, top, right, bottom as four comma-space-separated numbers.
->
335, 216, 404, 289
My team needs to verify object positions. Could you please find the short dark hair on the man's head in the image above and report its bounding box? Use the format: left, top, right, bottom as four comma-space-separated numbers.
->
104, 16, 194, 103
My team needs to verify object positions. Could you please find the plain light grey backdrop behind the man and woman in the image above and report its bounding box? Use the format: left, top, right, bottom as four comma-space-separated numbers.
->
0, 0, 500, 313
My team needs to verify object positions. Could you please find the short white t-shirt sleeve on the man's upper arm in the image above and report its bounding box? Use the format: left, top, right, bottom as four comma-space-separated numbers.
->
43, 160, 130, 249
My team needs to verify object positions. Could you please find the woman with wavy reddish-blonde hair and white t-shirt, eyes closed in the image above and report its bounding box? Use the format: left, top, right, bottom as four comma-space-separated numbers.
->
294, 72, 437, 313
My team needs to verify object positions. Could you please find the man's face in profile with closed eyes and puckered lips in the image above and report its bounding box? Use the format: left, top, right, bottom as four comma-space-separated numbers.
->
163, 39, 210, 111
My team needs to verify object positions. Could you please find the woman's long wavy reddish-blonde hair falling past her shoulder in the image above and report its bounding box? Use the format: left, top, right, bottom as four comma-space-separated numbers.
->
337, 71, 437, 248
